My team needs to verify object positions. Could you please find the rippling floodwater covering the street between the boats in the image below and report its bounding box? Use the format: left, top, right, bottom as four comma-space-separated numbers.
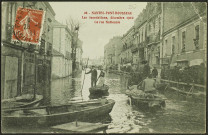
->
2, 71, 205, 133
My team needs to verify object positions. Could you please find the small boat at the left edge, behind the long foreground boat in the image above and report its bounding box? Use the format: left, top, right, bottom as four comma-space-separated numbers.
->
1, 95, 43, 109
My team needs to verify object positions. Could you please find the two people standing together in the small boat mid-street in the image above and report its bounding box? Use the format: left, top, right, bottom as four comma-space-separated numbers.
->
86, 66, 105, 87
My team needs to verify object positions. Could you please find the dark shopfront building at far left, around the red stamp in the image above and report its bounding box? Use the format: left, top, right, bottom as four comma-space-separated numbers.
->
1, 2, 55, 99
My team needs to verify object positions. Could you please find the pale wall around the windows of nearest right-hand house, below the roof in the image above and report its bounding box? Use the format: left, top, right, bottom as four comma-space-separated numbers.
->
163, 16, 206, 66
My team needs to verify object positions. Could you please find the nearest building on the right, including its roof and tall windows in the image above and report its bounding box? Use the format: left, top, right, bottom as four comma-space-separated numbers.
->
161, 2, 207, 67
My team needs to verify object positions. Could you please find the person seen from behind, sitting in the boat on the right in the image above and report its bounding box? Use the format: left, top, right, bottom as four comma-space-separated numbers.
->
142, 74, 156, 92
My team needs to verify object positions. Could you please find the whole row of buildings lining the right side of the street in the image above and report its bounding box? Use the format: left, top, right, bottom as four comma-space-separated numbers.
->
105, 2, 207, 74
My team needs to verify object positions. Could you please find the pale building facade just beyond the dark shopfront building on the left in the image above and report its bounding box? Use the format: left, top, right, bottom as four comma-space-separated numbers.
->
52, 21, 72, 79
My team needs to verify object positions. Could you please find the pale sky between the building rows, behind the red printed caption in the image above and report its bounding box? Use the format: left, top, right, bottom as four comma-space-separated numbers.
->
50, 2, 147, 59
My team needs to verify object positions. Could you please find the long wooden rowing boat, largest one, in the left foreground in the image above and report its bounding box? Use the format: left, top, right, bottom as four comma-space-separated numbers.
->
2, 99, 115, 127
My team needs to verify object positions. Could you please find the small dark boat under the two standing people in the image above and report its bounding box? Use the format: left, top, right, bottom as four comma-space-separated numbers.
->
89, 85, 109, 95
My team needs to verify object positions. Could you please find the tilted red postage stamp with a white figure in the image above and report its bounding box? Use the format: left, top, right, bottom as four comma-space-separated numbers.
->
12, 7, 45, 44
